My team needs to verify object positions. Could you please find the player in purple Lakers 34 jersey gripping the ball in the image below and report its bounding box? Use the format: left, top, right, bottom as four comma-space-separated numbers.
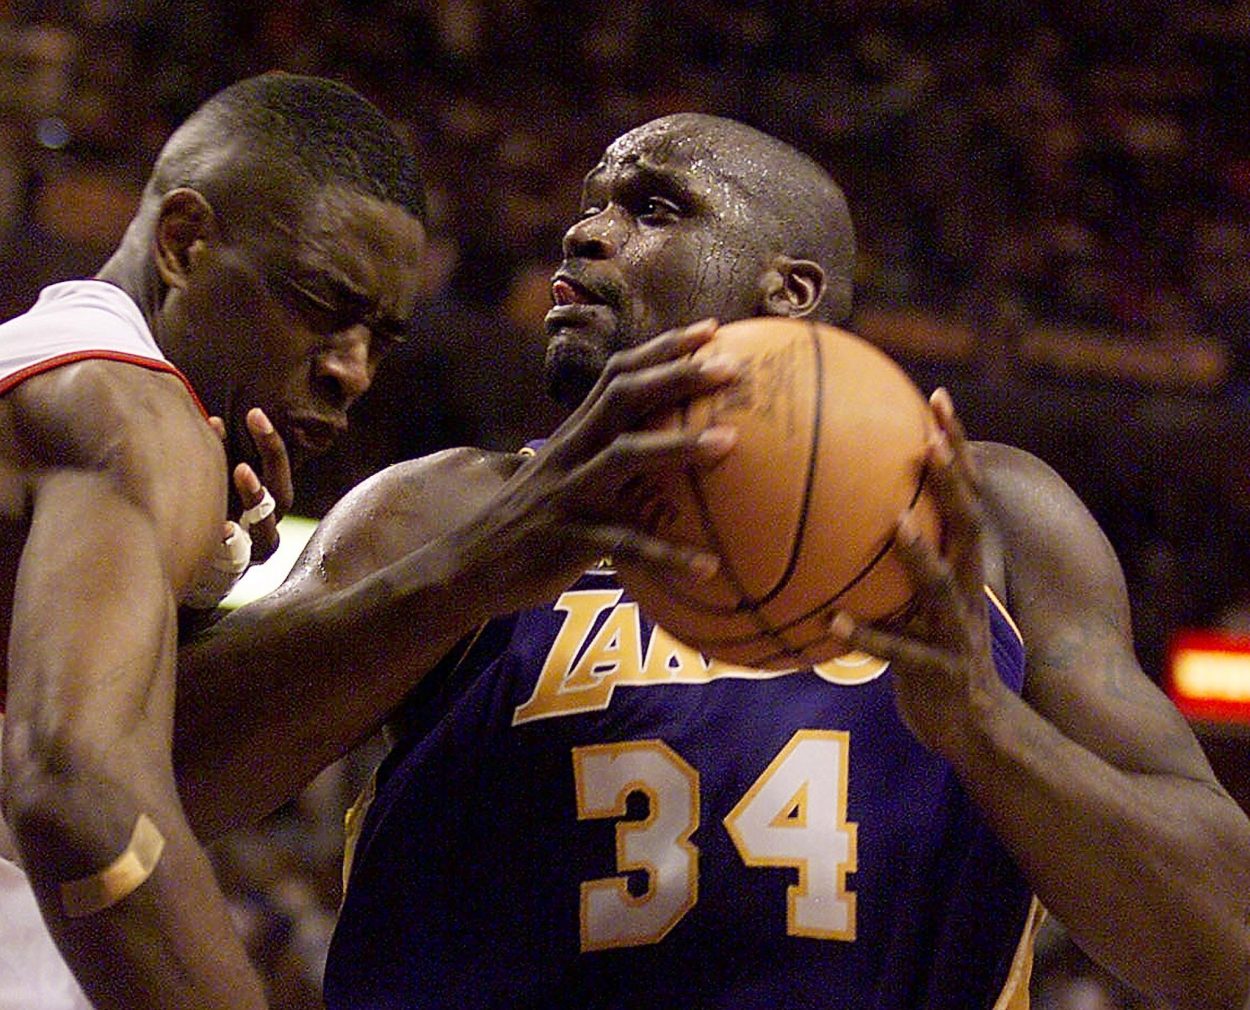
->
179, 115, 1250, 1010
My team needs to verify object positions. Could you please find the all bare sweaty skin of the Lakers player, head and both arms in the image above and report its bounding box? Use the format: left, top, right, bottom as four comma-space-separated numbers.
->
178, 115, 1250, 1010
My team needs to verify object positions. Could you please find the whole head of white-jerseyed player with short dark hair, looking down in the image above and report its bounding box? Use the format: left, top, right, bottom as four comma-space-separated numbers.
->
125, 74, 425, 475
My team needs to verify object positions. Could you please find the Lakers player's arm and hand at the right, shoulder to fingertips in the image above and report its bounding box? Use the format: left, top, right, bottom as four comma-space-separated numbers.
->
835, 393, 1250, 1010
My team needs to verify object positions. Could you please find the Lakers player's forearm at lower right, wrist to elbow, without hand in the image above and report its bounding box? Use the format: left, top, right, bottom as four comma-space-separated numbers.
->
948, 695, 1250, 1010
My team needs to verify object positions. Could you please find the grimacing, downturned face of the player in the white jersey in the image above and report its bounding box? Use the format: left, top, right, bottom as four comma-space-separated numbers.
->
175, 188, 425, 475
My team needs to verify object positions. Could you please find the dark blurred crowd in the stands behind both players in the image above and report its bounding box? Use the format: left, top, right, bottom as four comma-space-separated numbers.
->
0, 0, 1250, 1010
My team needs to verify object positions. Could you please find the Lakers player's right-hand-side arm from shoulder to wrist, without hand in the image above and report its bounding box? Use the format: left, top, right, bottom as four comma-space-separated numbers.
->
975, 446, 1250, 1008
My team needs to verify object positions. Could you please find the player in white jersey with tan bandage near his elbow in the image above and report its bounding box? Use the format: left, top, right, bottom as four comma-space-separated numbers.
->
0, 74, 424, 1010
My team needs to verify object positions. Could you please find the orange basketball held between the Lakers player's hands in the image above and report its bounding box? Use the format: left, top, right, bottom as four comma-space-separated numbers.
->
618, 318, 940, 670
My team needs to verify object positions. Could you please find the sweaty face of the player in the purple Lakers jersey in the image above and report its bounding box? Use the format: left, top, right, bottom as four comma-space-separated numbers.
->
546, 123, 766, 406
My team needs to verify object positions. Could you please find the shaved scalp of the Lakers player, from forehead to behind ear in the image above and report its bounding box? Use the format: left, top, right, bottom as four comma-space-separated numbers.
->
604, 113, 855, 323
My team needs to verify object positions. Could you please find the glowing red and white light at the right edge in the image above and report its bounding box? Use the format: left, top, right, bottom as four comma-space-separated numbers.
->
1164, 629, 1250, 725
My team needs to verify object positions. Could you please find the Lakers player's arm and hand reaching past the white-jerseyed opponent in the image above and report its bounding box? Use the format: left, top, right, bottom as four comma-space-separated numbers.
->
174, 324, 733, 835
